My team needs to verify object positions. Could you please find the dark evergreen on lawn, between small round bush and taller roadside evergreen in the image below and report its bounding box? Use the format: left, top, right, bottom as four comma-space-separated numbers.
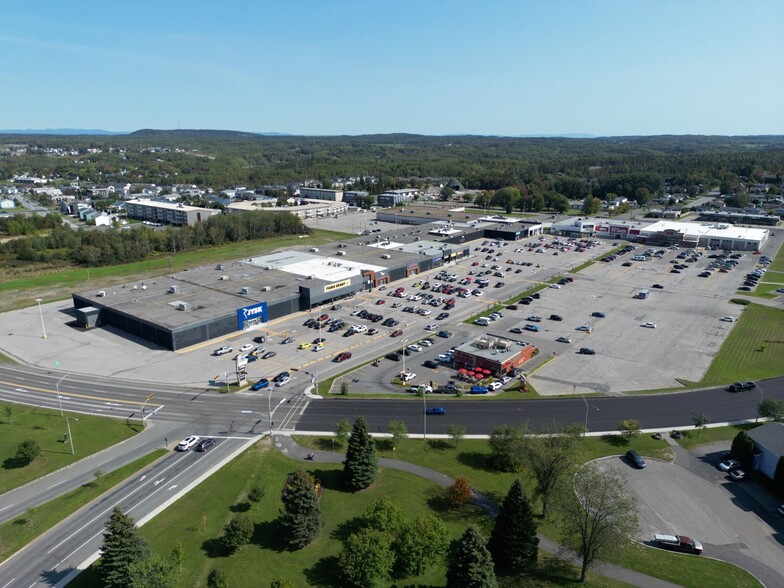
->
280, 468, 324, 549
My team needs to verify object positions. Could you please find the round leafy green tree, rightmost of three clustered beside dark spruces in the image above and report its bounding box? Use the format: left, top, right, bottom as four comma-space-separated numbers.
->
392, 515, 449, 578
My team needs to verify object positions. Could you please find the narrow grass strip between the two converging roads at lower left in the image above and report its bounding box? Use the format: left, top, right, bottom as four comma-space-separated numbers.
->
0, 449, 166, 561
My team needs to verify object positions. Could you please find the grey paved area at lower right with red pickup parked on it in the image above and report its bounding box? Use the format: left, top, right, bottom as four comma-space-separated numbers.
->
596, 456, 784, 586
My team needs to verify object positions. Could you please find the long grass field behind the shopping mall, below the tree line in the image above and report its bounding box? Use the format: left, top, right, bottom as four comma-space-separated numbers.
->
0, 229, 354, 312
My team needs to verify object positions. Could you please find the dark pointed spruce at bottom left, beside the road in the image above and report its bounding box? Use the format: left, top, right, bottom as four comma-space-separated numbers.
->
100, 506, 150, 588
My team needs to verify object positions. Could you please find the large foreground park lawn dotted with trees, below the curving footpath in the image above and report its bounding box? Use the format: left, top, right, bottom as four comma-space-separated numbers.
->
70, 444, 644, 588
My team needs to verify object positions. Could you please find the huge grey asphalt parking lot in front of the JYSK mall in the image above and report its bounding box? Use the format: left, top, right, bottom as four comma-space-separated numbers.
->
3, 223, 773, 395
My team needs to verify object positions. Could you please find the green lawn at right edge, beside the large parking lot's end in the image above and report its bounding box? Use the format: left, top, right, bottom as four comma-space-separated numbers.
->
700, 304, 784, 386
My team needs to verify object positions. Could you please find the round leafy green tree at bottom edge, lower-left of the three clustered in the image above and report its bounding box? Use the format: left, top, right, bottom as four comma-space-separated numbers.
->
338, 529, 395, 588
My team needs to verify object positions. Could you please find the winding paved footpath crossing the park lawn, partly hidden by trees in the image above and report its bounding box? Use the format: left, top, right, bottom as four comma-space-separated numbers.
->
275, 435, 678, 588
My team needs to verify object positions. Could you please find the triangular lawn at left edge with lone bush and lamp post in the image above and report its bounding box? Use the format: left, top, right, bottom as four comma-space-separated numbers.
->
0, 402, 143, 494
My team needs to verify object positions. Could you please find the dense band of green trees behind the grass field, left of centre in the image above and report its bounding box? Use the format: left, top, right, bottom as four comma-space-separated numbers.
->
0, 211, 309, 267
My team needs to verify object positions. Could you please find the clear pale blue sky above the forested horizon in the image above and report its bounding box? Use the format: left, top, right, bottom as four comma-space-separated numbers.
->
0, 0, 784, 135
